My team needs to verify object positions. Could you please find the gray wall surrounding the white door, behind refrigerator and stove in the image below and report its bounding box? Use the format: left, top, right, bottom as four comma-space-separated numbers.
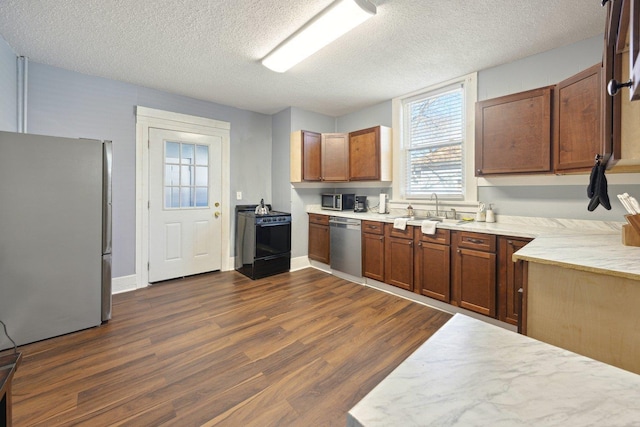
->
26, 62, 272, 277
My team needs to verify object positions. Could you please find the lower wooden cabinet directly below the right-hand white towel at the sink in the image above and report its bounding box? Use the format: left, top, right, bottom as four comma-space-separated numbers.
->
414, 227, 451, 302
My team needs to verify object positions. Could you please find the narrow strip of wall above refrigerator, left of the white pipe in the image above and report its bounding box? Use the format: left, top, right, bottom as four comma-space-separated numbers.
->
0, 37, 18, 132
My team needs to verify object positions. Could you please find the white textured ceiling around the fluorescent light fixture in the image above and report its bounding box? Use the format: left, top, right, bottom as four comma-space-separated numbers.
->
0, 0, 606, 116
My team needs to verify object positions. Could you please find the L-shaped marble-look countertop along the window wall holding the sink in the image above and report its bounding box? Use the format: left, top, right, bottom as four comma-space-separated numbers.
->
308, 206, 640, 280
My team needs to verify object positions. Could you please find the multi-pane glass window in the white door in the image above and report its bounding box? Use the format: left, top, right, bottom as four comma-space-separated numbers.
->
164, 141, 209, 209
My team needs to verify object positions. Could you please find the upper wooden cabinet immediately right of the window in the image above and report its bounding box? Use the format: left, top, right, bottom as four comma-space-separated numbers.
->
475, 86, 553, 176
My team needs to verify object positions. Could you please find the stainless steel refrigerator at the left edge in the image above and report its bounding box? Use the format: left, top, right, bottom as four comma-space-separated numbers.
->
0, 132, 112, 350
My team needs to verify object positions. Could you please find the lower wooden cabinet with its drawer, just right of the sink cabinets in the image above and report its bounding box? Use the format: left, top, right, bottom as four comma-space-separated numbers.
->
452, 231, 496, 317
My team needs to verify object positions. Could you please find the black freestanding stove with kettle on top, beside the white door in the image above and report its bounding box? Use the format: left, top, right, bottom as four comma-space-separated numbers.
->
235, 205, 291, 279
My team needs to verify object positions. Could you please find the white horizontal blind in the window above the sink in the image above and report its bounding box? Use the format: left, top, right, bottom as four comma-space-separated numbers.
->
404, 85, 464, 198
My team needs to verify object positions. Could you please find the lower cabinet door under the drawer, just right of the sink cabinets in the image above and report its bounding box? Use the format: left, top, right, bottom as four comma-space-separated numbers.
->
456, 248, 496, 317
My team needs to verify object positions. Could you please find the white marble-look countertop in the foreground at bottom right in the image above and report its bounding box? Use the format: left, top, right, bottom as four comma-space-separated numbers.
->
347, 314, 640, 427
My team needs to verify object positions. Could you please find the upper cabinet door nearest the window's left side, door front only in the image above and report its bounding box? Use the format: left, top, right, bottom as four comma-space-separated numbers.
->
349, 126, 380, 181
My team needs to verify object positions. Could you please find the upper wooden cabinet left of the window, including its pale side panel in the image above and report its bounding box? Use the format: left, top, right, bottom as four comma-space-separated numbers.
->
349, 126, 392, 181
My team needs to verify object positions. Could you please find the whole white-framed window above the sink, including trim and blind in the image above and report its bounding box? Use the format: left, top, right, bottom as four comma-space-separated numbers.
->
394, 74, 477, 201
